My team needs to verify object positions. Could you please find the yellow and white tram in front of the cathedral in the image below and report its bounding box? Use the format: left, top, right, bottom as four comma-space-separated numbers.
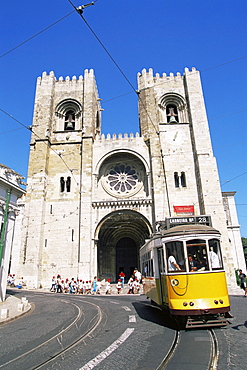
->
140, 217, 231, 327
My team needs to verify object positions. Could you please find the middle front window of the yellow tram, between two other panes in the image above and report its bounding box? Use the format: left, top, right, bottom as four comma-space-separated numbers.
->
186, 239, 208, 272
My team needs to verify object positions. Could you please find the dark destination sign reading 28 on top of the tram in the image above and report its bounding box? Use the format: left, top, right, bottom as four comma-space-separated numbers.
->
157, 215, 212, 231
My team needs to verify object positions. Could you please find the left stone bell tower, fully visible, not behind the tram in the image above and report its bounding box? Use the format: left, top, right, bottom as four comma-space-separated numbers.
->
14, 70, 101, 287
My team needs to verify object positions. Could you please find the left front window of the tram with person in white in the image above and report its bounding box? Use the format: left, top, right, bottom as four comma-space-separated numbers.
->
165, 241, 185, 272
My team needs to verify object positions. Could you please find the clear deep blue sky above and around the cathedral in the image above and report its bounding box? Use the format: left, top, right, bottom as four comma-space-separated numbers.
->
0, 0, 247, 237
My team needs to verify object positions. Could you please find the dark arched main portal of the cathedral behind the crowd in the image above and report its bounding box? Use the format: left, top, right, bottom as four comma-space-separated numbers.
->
96, 210, 152, 281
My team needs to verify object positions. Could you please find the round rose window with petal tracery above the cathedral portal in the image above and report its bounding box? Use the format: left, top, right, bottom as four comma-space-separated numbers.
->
103, 163, 142, 197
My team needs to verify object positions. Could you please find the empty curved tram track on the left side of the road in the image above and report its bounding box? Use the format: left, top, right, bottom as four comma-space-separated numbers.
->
0, 300, 103, 370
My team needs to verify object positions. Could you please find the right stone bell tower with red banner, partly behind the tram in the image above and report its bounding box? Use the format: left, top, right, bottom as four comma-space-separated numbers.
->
138, 68, 234, 279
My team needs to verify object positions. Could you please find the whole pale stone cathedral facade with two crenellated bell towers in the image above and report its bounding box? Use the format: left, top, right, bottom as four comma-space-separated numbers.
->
11, 68, 243, 287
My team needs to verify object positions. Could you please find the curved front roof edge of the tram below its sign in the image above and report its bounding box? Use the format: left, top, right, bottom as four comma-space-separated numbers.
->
161, 224, 220, 236
